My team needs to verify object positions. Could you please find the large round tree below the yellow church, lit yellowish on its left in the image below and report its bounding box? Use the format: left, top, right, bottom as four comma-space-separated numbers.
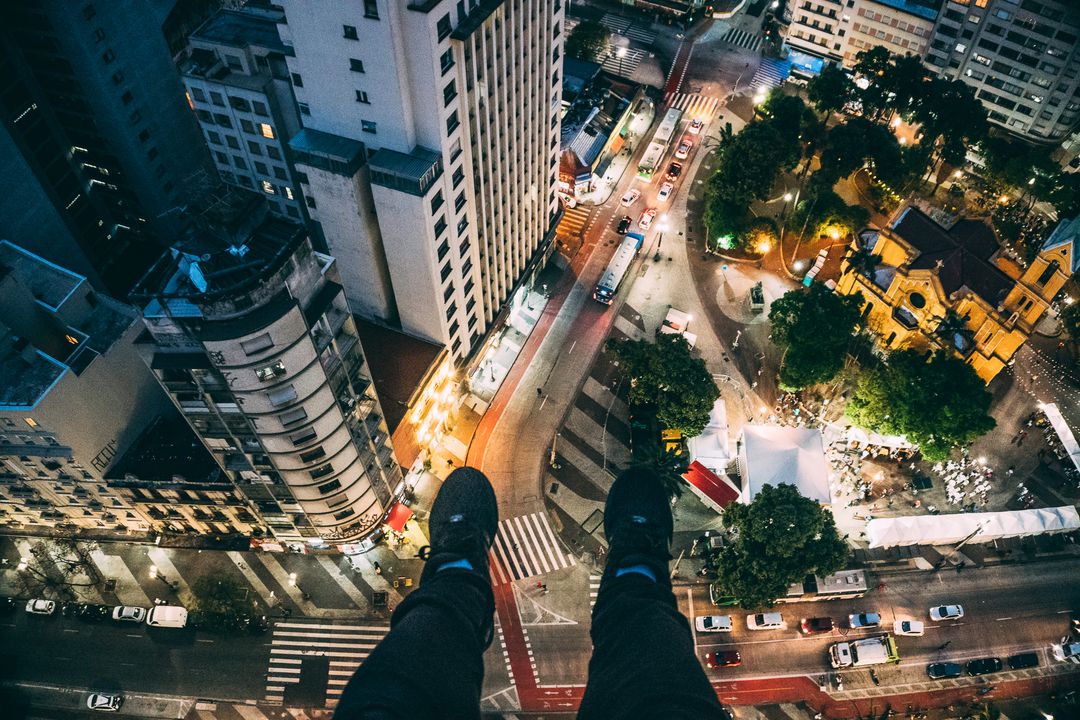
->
846, 350, 997, 461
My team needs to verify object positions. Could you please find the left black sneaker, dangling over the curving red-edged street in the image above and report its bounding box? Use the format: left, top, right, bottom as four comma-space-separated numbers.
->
422, 467, 499, 575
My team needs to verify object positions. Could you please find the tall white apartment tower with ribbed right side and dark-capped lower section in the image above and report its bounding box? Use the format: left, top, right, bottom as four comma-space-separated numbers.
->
279, 0, 564, 361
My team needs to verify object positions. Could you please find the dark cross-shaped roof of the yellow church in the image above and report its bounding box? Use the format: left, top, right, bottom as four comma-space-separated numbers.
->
892, 207, 1014, 305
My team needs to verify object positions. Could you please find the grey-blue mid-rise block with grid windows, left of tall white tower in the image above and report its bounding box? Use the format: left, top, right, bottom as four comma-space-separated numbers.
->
181, 8, 305, 220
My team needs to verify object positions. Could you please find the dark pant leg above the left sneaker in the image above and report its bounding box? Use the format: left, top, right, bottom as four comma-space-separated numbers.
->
334, 568, 495, 720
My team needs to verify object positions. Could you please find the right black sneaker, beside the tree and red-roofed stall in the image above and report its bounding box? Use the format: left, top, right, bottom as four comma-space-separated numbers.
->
604, 467, 675, 578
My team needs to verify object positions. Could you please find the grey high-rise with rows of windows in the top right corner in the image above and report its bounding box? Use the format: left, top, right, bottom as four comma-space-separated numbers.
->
926, 0, 1080, 142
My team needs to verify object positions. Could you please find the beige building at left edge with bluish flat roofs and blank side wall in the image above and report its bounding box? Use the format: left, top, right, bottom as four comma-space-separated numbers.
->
0, 241, 172, 532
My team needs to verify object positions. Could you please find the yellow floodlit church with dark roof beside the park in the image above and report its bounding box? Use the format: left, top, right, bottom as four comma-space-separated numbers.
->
836, 205, 1080, 383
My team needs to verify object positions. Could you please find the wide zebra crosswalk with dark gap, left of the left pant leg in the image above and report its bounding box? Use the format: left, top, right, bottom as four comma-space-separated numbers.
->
266, 621, 390, 705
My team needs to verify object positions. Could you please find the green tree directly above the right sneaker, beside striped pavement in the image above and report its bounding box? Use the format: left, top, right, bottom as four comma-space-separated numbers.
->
607, 330, 720, 437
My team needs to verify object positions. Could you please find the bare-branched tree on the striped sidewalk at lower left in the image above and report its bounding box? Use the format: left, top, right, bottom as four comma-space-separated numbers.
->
15, 538, 105, 601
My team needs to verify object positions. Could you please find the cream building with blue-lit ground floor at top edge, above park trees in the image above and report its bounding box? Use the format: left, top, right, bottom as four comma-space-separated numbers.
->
785, 0, 939, 74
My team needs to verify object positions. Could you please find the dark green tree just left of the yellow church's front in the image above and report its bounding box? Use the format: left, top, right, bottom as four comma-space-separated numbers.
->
769, 284, 863, 390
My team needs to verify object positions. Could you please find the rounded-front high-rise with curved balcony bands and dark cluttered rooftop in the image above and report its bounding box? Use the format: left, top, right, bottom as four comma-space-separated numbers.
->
132, 185, 404, 542
